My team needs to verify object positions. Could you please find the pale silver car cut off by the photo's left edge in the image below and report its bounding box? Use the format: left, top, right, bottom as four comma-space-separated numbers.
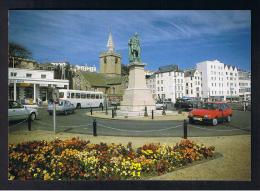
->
8, 101, 38, 121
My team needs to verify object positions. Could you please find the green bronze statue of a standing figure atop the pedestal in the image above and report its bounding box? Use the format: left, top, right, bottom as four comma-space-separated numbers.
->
128, 33, 141, 63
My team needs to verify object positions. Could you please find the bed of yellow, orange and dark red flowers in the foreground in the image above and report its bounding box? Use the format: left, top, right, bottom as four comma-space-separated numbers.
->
9, 138, 215, 180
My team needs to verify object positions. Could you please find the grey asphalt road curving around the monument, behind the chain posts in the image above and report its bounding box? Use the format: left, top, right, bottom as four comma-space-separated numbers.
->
9, 109, 251, 137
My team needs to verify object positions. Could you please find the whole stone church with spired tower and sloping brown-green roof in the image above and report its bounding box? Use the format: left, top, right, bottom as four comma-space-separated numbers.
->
73, 33, 128, 103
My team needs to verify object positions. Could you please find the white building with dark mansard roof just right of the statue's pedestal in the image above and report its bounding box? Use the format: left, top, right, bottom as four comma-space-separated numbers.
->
155, 65, 185, 103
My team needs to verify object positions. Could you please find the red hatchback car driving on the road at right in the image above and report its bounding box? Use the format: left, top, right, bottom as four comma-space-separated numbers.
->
188, 102, 233, 125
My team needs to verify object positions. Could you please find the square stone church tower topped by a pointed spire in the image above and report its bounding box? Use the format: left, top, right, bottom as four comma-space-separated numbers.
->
99, 32, 121, 76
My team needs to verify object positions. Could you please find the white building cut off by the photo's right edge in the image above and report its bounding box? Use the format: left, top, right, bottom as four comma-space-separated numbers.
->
238, 69, 251, 100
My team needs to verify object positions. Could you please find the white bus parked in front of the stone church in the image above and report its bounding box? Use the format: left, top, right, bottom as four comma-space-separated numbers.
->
59, 89, 104, 109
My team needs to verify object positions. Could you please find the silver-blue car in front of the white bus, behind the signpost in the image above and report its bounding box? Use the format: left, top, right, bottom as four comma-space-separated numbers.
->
47, 100, 76, 115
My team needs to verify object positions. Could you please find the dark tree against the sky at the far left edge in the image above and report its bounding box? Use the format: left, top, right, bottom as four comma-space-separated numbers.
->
8, 42, 32, 59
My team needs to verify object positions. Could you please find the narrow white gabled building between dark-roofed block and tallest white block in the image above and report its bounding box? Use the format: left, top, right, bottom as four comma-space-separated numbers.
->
184, 69, 202, 99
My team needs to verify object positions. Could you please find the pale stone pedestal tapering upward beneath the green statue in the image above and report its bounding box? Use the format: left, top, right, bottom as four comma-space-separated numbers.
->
120, 62, 155, 112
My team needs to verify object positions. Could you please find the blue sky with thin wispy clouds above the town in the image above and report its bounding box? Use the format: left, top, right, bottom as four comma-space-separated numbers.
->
9, 10, 251, 70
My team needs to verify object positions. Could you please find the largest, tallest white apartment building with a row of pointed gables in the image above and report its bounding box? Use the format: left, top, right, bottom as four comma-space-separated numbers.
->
197, 60, 239, 100
